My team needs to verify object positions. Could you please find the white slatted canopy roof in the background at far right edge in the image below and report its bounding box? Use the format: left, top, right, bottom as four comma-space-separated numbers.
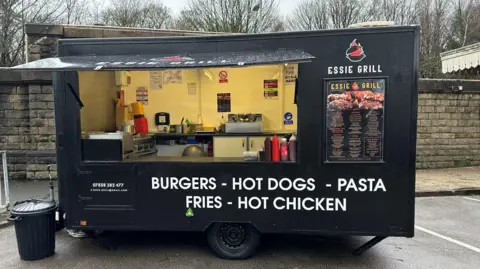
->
440, 43, 480, 73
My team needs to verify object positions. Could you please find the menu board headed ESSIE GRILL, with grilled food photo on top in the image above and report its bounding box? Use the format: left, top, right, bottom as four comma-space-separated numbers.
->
325, 79, 386, 162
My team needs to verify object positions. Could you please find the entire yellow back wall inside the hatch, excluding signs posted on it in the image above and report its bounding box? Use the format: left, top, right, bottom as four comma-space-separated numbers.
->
117, 65, 297, 132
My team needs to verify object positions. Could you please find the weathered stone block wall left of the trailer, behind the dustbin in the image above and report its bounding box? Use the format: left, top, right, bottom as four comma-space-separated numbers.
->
0, 70, 56, 180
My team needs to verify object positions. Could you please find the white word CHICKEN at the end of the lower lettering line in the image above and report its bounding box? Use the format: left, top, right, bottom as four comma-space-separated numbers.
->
273, 197, 347, 211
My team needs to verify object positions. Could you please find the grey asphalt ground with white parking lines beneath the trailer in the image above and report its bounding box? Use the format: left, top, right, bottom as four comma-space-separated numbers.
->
0, 196, 480, 269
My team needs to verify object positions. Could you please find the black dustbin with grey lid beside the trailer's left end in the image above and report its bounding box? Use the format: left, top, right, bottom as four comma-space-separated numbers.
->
9, 199, 57, 261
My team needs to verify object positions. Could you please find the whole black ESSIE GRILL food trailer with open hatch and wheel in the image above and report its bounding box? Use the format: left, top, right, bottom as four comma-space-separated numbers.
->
9, 26, 419, 259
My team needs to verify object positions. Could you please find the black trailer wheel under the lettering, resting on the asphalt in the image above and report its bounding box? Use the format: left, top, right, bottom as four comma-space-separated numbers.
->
207, 223, 260, 260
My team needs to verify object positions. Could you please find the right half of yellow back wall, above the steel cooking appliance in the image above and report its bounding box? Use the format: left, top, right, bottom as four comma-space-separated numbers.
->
201, 65, 283, 131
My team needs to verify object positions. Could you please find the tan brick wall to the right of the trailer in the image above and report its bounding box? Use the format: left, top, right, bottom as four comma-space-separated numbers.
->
417, 92, 480, 168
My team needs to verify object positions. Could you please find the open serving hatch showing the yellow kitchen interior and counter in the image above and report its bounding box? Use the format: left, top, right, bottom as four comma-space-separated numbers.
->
79, 64, 298, 162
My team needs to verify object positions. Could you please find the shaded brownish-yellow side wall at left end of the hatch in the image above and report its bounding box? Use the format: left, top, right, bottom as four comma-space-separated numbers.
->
78, 71, 117, 131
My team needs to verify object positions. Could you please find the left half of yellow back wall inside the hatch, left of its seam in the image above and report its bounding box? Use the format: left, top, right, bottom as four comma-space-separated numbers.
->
124, 69, 200, 132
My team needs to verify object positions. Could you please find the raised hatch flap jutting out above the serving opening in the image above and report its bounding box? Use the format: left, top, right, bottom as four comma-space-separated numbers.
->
11, 49, 315, 71
